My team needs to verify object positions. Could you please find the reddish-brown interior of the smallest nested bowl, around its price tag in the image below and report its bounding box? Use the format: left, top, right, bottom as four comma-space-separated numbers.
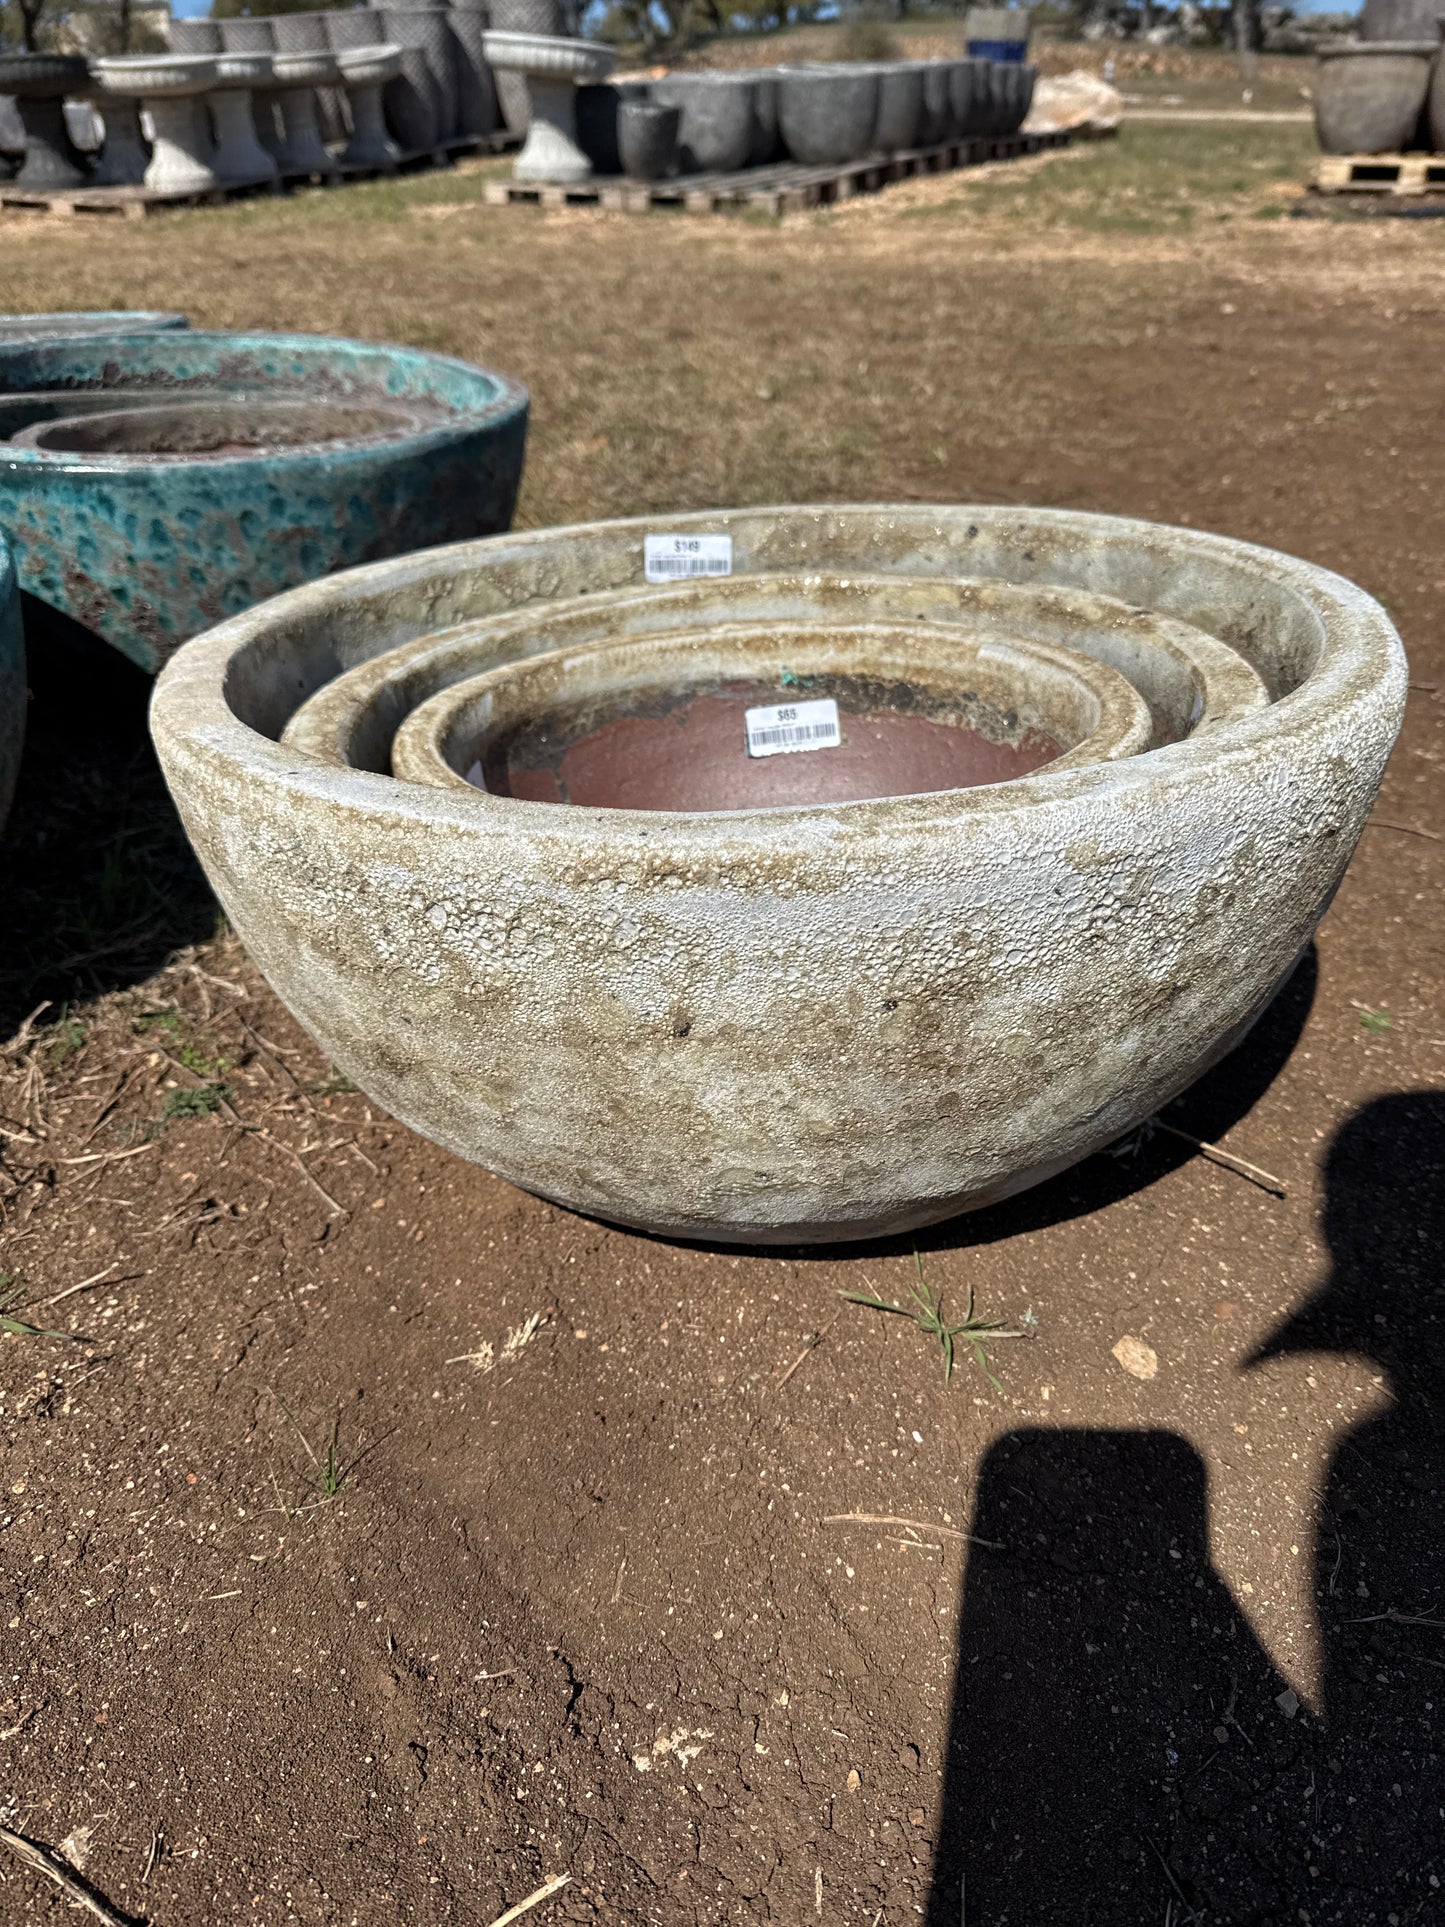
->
464, 674, 1064, 809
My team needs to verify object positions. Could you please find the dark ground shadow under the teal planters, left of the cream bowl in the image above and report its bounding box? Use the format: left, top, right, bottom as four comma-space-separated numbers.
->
0, 597, 218, 1037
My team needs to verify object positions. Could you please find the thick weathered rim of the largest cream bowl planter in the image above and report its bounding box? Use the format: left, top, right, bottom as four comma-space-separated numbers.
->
150, 503, 1406, 871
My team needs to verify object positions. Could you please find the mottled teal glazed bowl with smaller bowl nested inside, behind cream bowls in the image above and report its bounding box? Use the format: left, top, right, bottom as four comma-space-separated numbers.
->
0, 330, 528, 671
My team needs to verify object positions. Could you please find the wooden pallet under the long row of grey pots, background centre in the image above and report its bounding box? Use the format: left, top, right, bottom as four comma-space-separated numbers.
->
482, 133, 1069, 214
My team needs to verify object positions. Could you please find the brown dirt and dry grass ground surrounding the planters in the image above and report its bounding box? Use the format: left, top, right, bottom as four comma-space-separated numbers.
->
0, 101, 1445, 1927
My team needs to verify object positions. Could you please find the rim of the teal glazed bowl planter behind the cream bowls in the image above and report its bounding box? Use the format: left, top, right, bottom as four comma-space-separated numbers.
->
0, 328, 528, 477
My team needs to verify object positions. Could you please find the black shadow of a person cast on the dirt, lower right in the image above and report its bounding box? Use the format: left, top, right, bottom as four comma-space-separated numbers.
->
927, 1093, 1445, 1927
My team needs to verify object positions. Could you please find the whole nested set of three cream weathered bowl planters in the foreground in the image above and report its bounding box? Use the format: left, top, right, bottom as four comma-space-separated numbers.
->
152, 505, 1405, 1243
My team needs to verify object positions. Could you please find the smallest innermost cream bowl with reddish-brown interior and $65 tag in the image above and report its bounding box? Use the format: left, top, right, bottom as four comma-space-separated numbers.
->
391, 622, 1150, 811
